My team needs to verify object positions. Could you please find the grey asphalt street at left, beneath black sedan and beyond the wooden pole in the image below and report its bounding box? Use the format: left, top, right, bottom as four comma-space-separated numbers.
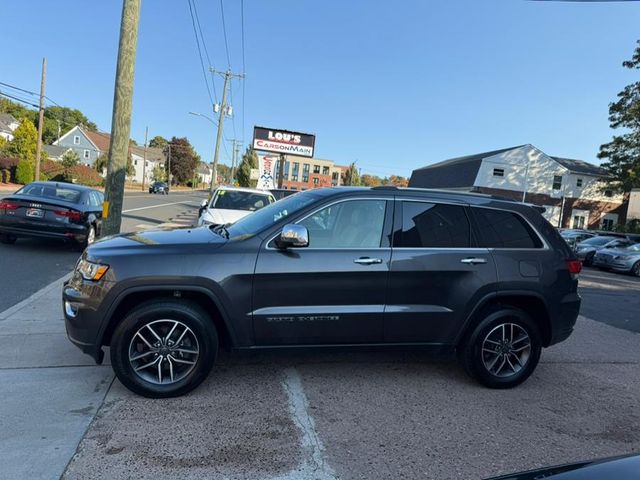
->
0, 192, 206, 311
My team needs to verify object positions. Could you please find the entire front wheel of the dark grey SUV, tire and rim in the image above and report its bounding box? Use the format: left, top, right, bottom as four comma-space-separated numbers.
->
111, 300, 218, 398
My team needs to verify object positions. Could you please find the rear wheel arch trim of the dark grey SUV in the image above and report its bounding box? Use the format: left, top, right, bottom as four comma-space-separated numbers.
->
456, 291, 552, 347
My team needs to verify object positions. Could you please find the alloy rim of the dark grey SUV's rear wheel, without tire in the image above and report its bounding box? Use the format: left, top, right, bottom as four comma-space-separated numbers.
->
482, 323, 531, 378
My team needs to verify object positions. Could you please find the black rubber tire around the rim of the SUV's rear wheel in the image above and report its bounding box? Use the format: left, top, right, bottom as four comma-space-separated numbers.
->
459, 306, 542, 388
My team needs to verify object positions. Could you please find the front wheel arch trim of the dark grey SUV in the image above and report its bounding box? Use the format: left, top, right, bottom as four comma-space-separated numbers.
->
99, 285, 236, 349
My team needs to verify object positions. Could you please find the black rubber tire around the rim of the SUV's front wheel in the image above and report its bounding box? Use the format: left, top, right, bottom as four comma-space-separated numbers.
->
111, 299, 218, 398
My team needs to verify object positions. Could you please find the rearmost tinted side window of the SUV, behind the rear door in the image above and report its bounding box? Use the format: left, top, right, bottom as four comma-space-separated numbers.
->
471, 207, 542, 248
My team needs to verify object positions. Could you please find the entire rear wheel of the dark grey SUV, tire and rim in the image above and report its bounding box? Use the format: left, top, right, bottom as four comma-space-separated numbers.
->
460, 307, 542, 388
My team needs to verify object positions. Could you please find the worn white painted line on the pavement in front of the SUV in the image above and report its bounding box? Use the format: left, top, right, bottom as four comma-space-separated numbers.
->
271, 368, 338, 480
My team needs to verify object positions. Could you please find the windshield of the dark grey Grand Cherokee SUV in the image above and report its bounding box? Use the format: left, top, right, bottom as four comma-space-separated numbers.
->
229, 190, 321, 238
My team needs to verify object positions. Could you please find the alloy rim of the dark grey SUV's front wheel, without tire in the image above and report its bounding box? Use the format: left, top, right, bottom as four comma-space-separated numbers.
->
129, 319, 200, 385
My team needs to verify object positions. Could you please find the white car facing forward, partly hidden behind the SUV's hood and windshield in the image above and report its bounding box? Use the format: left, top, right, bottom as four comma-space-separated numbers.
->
198, 187, 276, 226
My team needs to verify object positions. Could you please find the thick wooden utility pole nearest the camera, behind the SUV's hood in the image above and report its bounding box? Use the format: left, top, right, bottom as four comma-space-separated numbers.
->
102, 0, 140, 235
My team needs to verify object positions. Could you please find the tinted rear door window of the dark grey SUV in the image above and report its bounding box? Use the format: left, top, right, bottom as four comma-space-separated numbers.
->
393, 202, 471, 248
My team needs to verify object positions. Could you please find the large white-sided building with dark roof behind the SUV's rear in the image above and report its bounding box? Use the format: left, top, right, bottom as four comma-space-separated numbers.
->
409, 144, 626, 229
